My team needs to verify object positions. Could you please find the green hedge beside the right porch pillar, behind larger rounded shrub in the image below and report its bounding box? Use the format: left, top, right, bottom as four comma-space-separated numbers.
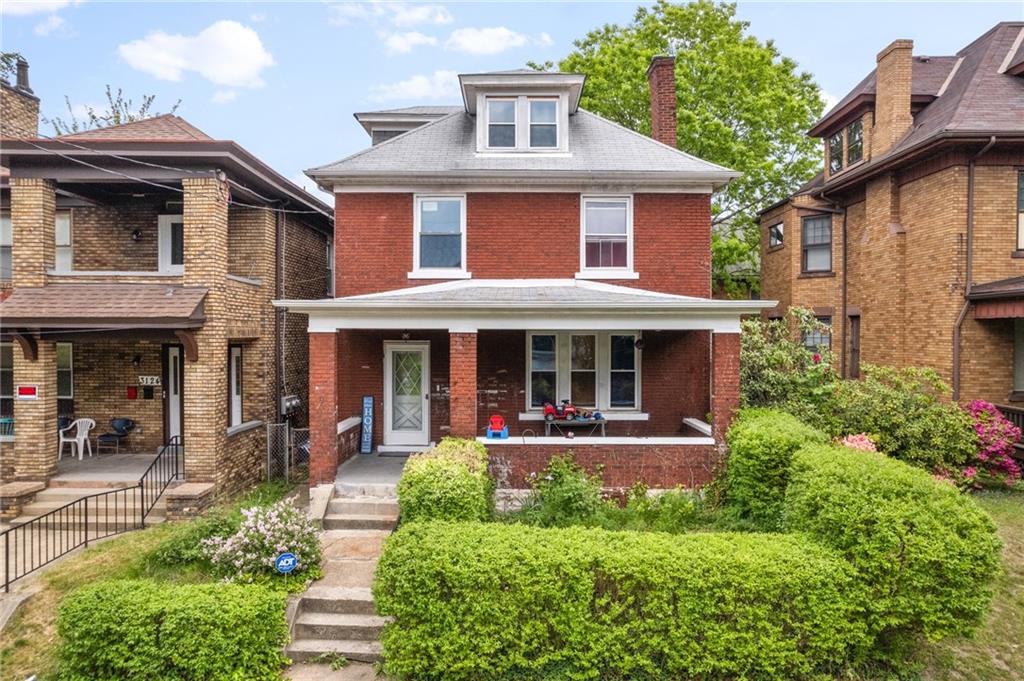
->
726, 409, 828, 527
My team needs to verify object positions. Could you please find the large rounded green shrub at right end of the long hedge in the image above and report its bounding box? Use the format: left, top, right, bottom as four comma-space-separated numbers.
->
785, 445, 999, 655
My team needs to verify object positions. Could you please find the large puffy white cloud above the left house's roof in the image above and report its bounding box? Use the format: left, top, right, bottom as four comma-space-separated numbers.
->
118, 20, 273, 87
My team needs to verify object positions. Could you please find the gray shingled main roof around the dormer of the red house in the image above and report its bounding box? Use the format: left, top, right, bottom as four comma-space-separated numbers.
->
306, 109, 738, 182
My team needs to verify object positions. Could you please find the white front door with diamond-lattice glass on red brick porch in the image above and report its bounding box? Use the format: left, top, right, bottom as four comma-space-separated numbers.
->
384, 342, 430, 445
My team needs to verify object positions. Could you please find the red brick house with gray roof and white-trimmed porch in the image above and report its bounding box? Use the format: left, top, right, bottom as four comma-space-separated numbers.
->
279, 57, 774, 487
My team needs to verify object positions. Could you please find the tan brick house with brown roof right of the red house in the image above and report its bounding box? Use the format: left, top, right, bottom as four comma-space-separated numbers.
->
761, 22, 1024, 403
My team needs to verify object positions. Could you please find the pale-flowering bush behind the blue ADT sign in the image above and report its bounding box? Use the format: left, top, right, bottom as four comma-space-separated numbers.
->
203, 502, 321, 582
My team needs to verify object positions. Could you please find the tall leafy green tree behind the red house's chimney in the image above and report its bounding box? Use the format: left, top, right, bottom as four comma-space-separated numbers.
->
557, 0, 824, 295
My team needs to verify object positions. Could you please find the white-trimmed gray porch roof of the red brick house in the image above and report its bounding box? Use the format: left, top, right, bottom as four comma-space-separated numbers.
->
274, 279, 775, 332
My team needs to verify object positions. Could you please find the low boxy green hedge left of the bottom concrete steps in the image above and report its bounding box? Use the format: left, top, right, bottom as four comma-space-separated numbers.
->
57, 581, 288, 681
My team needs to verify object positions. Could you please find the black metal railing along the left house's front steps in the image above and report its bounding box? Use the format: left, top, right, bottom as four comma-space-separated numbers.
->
0, 436, 184, 592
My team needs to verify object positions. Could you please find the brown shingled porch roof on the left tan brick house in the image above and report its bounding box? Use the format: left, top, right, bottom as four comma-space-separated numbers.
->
0, 284, 207, 331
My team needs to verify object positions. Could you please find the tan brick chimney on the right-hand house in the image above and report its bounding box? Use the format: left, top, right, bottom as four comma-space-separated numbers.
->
871, 40, 913, 156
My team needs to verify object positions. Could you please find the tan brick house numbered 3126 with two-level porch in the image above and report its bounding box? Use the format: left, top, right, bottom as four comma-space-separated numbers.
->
0, 62, 333, 491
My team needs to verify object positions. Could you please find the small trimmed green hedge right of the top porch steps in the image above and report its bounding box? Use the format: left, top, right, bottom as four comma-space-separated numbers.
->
397, 437, 495, 522
